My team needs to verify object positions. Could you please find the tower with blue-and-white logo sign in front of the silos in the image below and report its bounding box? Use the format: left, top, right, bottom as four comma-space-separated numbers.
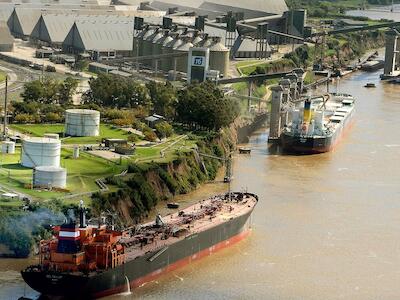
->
187, 48, 210, 83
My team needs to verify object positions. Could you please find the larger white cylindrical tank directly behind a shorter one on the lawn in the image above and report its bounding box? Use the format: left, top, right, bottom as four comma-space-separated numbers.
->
21, 137, 61, 168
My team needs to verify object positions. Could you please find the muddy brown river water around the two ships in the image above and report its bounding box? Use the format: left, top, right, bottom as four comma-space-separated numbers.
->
0, 69, 400, 300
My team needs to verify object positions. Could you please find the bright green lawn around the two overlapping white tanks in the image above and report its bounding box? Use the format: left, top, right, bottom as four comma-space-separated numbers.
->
0, 148, 122, 206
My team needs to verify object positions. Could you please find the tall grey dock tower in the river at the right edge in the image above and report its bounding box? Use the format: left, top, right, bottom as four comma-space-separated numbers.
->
381, 29, 400, 79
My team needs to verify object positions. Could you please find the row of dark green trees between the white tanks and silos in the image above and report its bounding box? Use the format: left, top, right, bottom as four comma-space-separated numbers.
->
17, 74, 239, 131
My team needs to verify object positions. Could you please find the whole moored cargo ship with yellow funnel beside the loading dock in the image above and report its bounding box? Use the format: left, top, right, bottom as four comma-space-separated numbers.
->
281, 93, 355, 154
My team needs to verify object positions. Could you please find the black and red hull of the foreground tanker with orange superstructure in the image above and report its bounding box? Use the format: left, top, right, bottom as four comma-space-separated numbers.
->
22, 212, 251, 299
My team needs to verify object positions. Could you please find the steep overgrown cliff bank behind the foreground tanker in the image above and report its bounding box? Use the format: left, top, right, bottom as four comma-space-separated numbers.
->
92, 129, 236, 226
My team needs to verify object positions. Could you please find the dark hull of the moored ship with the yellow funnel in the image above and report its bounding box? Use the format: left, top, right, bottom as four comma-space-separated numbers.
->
281, 112, 353, 154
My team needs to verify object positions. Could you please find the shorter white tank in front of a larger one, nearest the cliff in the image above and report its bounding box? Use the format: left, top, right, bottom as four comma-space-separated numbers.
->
32, 166, 67, 188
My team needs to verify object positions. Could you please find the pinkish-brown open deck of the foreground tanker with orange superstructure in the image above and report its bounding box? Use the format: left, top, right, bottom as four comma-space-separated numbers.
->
121, 194, 257, 261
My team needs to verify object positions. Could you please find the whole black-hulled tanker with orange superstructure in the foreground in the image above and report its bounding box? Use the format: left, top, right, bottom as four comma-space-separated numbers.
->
21, 192, 258, 299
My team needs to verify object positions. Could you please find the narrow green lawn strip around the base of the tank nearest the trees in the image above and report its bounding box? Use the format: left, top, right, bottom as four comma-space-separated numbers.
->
10, 124, 132, 144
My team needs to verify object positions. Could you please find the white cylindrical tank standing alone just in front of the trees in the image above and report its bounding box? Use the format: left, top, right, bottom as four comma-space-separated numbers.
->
65, 109, 100, 136
